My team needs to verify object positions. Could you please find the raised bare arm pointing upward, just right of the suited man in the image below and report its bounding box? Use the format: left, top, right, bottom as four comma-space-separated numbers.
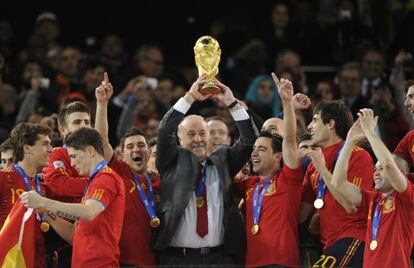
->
272, 73, 300, 169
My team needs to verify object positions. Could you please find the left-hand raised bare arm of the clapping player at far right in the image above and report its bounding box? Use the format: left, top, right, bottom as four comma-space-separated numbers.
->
332, 120, 364, 209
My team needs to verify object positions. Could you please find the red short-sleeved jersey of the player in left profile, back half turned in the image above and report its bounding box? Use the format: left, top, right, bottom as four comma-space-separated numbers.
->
72, 167, 125, 267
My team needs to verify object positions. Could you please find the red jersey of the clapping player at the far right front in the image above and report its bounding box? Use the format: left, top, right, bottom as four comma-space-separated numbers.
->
359, 181, 414, 268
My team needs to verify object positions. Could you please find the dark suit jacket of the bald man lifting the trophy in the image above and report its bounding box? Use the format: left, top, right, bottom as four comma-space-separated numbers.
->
152, 108, 258, 254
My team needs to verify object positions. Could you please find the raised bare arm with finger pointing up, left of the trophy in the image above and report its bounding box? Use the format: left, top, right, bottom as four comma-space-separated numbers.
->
95, 72, 114, 161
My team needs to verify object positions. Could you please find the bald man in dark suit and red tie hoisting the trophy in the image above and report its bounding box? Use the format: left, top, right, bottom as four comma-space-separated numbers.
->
153, 76, 258, 266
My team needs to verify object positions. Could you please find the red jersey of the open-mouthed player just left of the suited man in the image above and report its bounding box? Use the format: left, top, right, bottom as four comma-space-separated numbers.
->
109, 158, 160, 266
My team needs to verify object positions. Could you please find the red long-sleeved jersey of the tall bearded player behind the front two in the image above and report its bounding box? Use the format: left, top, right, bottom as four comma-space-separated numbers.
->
43, 147, 88, 203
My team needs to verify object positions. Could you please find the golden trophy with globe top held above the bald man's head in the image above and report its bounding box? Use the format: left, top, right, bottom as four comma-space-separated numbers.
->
194, 35, 222, 95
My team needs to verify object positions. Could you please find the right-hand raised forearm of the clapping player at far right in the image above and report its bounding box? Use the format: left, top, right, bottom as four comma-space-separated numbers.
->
358, 109, 407, 193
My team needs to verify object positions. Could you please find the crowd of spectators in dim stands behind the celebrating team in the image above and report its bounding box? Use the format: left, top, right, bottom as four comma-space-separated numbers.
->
0, 0, 414, 149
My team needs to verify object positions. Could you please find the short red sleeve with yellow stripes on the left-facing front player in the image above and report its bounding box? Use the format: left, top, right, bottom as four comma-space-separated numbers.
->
85, 170, 119, 208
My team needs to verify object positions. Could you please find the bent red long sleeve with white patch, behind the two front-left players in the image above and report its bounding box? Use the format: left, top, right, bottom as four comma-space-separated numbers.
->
43, 150, 88, 197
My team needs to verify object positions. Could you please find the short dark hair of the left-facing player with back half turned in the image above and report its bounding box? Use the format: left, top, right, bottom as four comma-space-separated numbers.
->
65, 127, 103, 156
